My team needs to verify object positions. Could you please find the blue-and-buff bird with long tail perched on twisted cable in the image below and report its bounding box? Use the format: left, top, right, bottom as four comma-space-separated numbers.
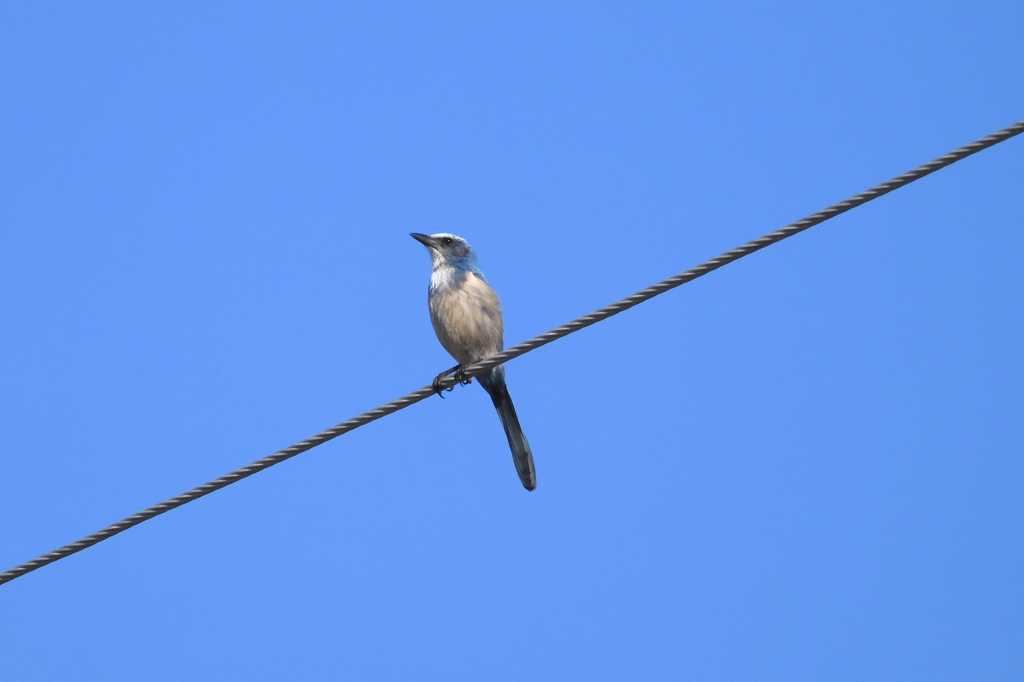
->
410, 232, 537, 491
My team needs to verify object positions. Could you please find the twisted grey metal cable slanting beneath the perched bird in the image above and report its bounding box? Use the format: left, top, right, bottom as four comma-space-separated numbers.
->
0, 116, 1024, 585
